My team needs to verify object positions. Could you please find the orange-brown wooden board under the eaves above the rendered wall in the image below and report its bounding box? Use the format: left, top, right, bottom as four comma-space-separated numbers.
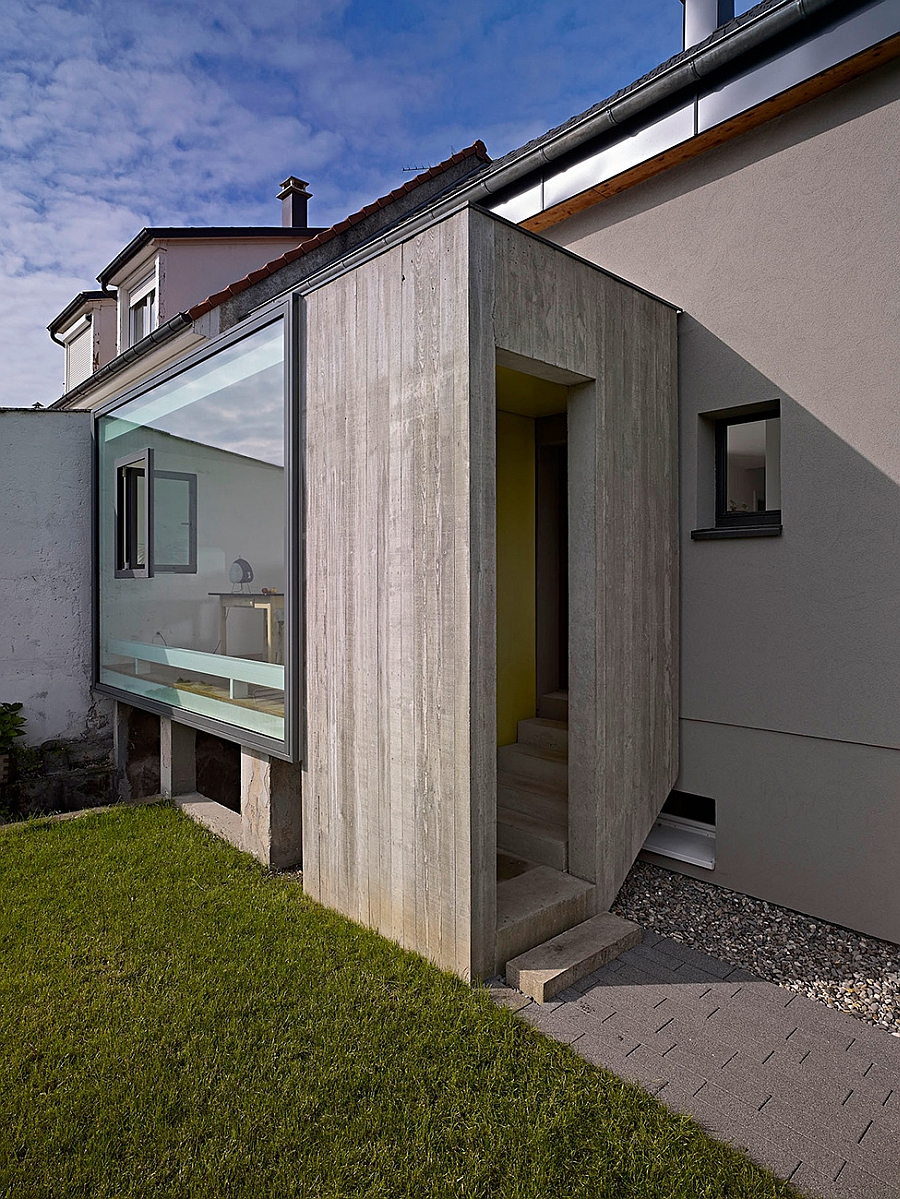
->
521, 34, 900, 233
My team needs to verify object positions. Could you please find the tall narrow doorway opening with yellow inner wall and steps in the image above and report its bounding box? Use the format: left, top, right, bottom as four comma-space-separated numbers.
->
497, 354, 569, 875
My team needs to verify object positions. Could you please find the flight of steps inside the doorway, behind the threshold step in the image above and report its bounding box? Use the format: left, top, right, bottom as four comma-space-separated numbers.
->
497, 691, 569, 872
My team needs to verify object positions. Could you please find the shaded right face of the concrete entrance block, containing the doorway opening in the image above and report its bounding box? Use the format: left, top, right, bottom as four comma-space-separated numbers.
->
489, 222, 678, 911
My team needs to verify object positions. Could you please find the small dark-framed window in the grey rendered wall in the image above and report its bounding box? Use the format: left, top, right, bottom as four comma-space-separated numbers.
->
715, 409, 781, 529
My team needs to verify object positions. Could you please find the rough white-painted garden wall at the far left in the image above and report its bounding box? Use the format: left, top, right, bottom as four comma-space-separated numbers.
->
0, 409, 109, 745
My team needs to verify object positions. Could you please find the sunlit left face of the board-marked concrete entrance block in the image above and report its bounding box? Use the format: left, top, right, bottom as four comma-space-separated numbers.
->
302, 212, 488, 976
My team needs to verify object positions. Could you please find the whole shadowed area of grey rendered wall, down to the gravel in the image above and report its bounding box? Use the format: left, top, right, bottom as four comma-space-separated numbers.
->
677, 318, 900, 940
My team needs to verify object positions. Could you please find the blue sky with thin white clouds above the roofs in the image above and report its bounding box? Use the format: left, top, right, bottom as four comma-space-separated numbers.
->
0, 0, 709, 406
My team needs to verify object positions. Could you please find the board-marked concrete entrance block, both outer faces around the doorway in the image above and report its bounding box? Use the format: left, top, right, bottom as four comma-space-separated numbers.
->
302, 209, 677, 976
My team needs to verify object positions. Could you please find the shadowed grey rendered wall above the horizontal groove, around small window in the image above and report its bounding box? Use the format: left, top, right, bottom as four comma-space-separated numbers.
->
679, 318, 900, 749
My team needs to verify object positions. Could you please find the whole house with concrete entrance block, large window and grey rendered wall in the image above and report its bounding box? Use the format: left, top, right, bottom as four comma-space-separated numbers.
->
21, 0, 900, 976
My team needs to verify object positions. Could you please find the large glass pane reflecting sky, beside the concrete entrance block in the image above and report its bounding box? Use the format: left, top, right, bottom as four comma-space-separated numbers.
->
98, 318, 288, 742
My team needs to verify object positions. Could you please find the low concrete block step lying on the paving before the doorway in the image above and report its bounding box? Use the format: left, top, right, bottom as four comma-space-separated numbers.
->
508, 911, 644, 1004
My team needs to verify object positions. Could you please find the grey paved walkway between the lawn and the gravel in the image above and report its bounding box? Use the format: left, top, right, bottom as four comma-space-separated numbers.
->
495, 930, 900, 1199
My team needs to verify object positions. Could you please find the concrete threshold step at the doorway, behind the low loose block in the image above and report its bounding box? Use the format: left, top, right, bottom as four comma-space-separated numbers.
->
496, 866, 597, 970
